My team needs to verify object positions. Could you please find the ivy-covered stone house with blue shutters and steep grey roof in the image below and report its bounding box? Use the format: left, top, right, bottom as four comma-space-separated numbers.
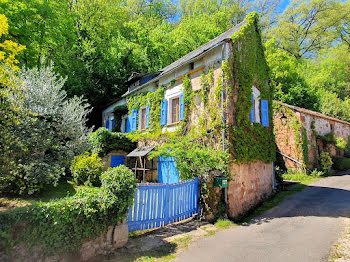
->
102, 13, 275, 218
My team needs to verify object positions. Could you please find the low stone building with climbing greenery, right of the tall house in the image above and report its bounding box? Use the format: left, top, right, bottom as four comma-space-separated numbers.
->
274, 101, 350, 169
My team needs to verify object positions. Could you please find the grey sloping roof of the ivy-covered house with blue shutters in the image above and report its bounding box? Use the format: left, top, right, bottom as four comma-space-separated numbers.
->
122, 20, 246, 97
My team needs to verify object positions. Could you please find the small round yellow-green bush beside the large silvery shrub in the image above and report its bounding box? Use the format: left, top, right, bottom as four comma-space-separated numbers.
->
70, 152, 104, 186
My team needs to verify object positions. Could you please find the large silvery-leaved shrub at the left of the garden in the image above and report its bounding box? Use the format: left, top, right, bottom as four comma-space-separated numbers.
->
0, 62, 90, 194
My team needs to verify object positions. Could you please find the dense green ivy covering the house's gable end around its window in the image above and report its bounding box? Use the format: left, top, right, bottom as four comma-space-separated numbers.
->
230, 13, 275, 162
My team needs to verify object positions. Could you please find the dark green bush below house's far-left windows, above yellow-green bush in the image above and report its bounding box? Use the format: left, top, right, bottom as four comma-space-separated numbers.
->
89, 127, 136, 157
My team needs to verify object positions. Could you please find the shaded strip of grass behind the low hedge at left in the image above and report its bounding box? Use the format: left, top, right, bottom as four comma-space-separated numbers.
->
0, 180, 76, 211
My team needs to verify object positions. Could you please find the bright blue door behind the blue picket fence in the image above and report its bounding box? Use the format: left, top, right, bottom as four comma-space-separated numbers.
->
158, 156, 179, 184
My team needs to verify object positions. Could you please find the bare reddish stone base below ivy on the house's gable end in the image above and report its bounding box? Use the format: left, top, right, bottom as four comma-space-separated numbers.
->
227, 161, 273, 218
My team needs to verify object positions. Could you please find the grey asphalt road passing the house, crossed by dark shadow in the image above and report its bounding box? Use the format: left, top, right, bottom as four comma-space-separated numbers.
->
175, 175, 350, 262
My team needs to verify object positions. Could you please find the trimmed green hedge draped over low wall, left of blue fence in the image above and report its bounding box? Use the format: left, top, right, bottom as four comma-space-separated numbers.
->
0, 166, 136, 254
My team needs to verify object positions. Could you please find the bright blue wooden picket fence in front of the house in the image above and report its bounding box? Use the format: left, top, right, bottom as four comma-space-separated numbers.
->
127, 178, 198, 232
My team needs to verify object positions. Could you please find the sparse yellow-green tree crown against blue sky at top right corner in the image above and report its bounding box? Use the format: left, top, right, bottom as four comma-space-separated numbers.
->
268, 0, 349, 59
